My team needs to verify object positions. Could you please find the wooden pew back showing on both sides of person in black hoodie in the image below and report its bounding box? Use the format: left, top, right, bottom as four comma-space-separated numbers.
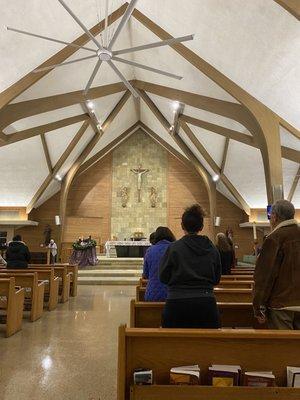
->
130, 299, 266, 329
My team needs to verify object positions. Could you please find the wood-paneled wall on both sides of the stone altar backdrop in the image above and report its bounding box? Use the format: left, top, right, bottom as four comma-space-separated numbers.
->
18, 147, 262, 259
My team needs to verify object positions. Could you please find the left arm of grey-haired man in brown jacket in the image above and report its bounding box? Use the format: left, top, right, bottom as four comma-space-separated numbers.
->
253, 237, 279, 315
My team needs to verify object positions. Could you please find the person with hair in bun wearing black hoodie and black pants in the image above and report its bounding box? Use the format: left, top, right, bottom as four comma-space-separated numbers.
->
159, 204, 221, 328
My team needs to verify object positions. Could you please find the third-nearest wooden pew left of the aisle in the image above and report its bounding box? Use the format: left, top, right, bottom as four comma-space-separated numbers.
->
0, 267, 59, 311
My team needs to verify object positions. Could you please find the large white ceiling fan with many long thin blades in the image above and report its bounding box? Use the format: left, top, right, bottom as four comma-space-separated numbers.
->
7, 0, 194, 98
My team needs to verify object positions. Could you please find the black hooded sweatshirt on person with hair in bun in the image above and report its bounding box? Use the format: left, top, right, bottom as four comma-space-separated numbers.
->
159, 234, 221, 299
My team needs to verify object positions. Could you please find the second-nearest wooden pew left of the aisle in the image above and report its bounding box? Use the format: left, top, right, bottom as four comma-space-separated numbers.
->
0, 272, 45, 322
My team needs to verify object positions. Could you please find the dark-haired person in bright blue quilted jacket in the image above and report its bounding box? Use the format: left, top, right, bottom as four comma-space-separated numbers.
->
143, 226, 176, 301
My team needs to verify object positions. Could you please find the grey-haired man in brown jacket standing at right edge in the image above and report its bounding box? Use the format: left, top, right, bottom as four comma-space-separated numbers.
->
253, 200, 300, 329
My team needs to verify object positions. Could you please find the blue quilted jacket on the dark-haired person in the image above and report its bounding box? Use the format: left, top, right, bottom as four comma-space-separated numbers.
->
143, 240, 170, 301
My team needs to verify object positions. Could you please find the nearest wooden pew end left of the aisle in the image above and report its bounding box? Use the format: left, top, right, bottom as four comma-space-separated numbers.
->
0, 278, 25, 337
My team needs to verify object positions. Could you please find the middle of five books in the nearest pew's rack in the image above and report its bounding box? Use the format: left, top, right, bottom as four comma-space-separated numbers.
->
208, 364, 241, 387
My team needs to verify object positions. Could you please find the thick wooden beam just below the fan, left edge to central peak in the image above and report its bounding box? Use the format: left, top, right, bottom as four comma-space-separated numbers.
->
0, 82, 126, 129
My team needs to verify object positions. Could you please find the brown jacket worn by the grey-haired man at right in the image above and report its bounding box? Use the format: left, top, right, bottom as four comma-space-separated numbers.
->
253, 220, 300, 313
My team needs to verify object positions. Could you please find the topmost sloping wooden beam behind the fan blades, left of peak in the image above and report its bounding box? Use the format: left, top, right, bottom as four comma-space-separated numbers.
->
0, 3, 127, 109
